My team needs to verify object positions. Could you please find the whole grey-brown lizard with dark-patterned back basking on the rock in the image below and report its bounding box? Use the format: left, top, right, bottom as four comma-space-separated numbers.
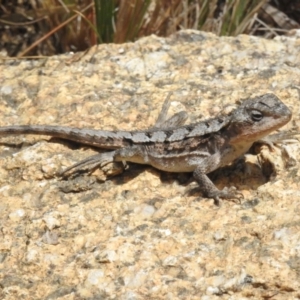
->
0, 93, 292, 204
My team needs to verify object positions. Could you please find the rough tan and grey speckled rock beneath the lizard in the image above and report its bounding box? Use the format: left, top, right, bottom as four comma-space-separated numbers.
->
0, 31, 300, 300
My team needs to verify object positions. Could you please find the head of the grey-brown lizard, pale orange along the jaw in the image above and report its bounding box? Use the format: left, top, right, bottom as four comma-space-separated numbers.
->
226, 94, 292, 143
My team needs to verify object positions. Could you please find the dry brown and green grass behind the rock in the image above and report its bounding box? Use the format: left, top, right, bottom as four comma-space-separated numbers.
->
0, 0, 299, 57
